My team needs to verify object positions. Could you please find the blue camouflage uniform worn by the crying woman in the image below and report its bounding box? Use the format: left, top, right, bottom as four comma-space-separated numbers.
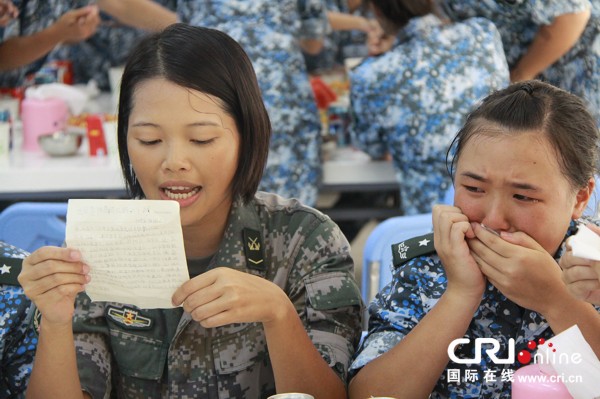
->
350, 221, 598, 399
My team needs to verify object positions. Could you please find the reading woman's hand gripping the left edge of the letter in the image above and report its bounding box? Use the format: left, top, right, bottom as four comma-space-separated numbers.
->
18, 247, 90, 325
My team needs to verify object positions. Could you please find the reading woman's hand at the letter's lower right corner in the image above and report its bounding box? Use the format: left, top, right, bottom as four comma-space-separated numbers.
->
173, 267, 296, 328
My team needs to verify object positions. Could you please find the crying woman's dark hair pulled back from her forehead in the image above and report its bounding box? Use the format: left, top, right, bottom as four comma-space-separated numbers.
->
446, 80, 599, 189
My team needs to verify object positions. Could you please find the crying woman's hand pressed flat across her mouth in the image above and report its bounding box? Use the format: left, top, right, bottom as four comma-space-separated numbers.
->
468, 223, 567, 314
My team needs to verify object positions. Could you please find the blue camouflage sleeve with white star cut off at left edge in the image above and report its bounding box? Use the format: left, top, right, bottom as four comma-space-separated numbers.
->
0, 241, 37, 398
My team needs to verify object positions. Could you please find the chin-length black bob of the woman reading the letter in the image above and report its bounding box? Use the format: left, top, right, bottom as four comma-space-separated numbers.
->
117, 23, 271, 202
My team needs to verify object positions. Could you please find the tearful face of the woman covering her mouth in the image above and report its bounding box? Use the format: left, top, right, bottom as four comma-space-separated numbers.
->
454, 132, 593, 254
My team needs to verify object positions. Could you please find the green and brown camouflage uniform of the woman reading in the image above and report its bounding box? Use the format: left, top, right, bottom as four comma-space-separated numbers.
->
69, 193, 362, 398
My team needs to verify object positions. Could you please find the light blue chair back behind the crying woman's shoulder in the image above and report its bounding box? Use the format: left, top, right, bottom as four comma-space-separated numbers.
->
361, 213, 433, 303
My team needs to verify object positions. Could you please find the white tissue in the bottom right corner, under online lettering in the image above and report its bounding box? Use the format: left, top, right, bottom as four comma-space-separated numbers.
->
535, 325, 600, 399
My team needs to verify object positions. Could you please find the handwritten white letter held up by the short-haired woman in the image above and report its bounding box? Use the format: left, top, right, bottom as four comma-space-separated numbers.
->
66, 199, 190, 309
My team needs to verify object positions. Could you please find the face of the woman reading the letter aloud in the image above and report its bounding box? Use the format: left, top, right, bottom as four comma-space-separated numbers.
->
127, 78, 240, 228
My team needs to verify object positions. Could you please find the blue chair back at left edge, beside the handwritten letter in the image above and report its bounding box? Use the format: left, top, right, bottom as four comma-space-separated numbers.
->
0, 202, 67, 252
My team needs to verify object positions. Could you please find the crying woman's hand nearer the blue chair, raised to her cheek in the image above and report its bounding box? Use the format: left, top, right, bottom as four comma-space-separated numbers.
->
432, 205, 486, 301
